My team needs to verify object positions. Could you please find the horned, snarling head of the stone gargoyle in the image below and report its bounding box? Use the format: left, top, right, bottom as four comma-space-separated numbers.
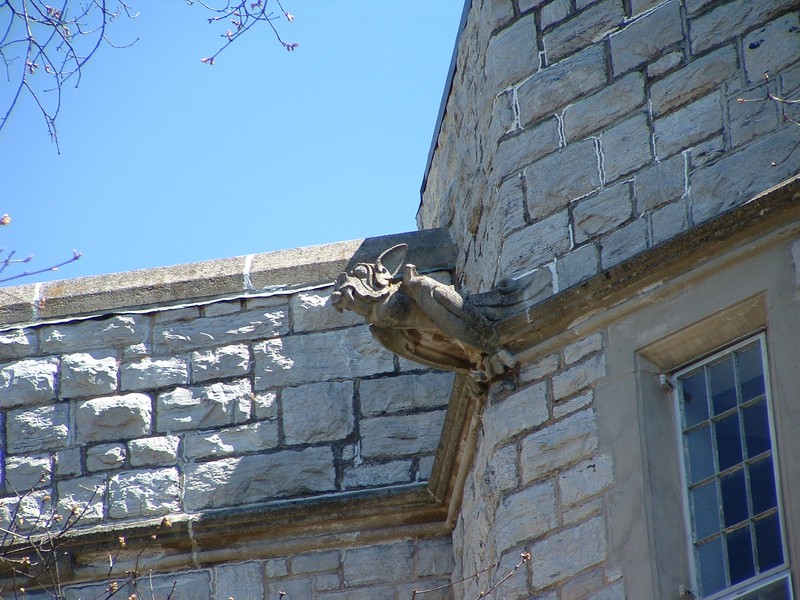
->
331, 244, 408, 317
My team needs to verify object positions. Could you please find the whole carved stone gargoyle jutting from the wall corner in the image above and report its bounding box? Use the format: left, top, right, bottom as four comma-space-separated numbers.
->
331, 244, 516, 380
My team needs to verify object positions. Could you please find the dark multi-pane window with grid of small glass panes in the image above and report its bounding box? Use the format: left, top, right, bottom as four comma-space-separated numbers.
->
673, 335, 792, 600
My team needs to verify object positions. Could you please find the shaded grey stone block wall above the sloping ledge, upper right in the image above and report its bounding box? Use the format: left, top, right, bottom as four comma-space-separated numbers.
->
418, 0, 800, 293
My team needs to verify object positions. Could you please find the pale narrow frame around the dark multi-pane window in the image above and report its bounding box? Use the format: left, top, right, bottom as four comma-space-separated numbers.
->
669, 330, 794, 600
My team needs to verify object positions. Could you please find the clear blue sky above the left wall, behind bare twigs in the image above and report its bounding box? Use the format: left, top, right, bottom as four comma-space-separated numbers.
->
0, 0, 463, 283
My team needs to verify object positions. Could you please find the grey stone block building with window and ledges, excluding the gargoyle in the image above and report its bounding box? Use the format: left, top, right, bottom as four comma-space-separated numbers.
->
0, 0, 800, 600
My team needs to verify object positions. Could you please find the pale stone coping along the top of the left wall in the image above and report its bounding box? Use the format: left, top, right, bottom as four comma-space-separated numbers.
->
0, 228, 455, 328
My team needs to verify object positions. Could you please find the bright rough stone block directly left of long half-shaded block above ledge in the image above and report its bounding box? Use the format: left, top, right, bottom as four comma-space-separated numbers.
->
108, 468, 181, 519
